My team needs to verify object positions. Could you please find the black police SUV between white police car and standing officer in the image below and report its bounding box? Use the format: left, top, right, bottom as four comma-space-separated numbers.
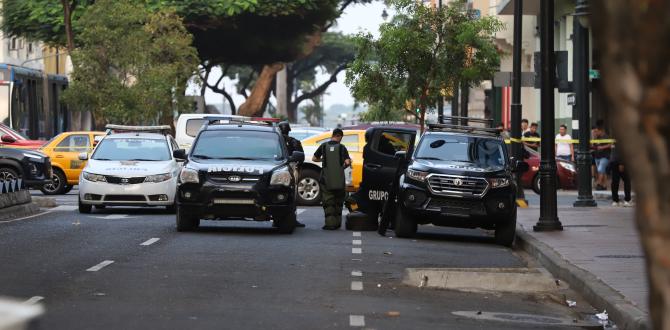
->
174, 117, 305, 233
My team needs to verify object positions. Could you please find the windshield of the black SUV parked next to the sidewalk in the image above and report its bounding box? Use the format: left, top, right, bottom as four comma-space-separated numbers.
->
415, 134, 506, 167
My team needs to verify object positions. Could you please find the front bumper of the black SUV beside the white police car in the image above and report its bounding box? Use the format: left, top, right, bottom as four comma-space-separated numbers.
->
177, 183, 295, 220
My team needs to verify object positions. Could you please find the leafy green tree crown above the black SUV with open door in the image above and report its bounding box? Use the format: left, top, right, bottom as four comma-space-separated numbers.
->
346, 0, 502, 129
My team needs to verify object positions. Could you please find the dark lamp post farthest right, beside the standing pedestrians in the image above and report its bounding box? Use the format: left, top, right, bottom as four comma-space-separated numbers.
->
573, 0, 598, 207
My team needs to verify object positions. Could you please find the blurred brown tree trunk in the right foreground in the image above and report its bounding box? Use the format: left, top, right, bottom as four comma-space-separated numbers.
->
590, 0, 670, 329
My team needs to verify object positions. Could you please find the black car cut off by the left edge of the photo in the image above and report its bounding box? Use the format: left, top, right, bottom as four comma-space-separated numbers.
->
0, 148, 51, 188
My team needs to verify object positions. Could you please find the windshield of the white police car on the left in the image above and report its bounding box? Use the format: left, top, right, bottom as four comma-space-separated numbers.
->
91, 138, 172, 161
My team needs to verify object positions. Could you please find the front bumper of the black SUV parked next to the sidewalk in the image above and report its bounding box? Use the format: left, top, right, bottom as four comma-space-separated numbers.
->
398, 184, 516, 229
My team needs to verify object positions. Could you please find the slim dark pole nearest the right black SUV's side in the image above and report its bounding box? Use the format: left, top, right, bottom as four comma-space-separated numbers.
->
510, 0, 526, 201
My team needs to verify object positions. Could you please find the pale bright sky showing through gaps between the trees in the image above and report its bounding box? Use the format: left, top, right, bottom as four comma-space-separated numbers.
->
188, 1, 391, 109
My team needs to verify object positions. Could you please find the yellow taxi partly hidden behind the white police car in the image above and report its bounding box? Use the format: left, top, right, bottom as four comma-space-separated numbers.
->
39, 131, 105, 195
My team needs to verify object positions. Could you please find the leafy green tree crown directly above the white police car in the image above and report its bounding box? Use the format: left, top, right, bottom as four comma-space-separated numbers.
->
63, 0, 198, 128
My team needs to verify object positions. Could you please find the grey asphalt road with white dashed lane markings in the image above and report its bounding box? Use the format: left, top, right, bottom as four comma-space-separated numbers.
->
0, 190, 600, 329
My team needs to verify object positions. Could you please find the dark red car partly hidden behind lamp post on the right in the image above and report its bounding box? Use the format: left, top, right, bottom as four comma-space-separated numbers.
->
521, 147, 577, 194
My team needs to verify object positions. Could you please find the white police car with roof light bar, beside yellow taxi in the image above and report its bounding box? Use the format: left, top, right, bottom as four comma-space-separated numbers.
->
79, 125, 181, 213
